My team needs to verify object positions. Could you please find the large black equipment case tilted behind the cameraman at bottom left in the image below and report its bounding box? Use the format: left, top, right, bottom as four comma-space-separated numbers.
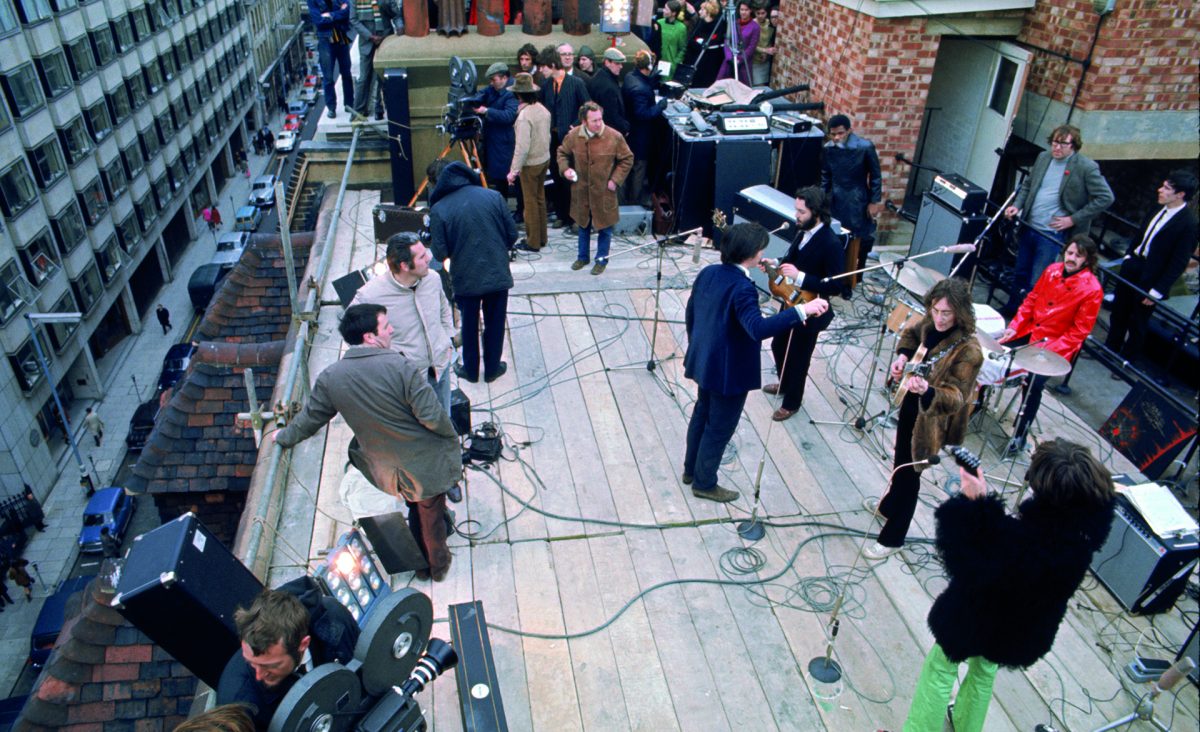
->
113, 514, 263, 689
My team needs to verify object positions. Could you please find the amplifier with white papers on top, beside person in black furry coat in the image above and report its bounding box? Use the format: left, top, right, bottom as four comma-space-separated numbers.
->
1092, 496, 1200, 614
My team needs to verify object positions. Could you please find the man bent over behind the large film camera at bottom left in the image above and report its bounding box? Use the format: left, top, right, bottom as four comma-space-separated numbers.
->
217, 576, 359, 730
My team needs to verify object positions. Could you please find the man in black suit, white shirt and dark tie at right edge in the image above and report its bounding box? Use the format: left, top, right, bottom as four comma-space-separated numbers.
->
1104, 170, 1198, 360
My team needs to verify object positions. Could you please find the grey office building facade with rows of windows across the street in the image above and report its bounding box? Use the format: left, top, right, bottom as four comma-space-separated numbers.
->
0, 0, 256, 492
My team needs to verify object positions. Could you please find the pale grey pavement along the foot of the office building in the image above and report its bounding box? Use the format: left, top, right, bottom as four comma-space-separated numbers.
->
0, 106, 283, 697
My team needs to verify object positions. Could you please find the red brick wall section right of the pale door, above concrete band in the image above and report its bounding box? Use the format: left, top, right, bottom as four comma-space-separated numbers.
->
1019, 0, 1200, 112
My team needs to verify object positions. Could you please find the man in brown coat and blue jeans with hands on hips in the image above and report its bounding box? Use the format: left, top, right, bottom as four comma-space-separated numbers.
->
558, 102, 634, 275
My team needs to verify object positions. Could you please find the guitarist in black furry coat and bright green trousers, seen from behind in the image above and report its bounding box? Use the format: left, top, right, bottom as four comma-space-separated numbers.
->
904, 439, 1114, 732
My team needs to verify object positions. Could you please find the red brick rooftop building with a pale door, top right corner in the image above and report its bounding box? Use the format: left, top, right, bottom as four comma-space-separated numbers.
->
773, 0, 1200, 228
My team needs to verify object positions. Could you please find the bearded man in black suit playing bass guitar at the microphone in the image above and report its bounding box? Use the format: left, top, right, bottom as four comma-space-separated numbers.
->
762, 186, 846, 422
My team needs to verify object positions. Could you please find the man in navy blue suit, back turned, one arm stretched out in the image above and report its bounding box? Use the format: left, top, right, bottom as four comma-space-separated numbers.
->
680, 223, 829, 503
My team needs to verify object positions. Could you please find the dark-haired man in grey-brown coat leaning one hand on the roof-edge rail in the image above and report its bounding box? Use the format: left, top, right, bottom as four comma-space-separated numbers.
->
275, 304, 462, 582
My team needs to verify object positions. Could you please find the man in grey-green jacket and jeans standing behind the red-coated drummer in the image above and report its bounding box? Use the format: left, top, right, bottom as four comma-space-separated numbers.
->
1002, 125, 1112, 317
